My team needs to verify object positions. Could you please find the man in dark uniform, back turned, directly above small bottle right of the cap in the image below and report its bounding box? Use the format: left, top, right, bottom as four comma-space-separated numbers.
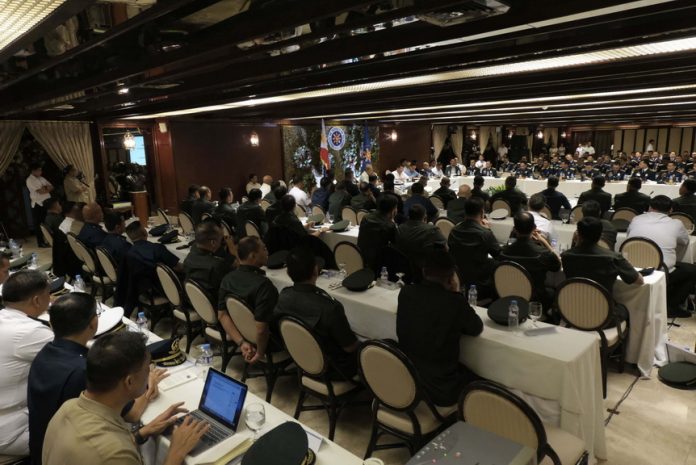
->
358, 195, 398, 275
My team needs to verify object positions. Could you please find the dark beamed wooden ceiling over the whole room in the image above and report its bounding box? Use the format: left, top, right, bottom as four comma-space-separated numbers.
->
0, 0, 696, 125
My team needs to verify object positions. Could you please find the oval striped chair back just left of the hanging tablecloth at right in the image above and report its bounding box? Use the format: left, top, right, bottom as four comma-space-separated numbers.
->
556, 278, 614, 331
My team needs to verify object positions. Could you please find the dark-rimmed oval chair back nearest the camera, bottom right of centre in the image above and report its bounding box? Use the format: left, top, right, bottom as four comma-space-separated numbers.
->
459, 381, 547, 463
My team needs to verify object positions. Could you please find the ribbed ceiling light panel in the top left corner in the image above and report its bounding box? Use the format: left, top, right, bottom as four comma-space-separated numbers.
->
0, 0, 65, 50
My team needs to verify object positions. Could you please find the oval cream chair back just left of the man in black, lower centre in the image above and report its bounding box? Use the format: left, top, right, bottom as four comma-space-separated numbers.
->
358, 341, 420, 410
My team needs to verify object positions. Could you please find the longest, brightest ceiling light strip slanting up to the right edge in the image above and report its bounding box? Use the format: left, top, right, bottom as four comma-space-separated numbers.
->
127, 37, 696, 119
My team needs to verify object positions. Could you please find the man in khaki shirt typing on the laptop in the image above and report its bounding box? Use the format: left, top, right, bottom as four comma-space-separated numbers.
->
42, 331, 209, 465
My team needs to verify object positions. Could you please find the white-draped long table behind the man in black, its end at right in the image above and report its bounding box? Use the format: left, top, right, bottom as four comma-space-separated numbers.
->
267, 270, 607, 459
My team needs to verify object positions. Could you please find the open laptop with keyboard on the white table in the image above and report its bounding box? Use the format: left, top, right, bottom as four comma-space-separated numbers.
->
177, 368, 248, 456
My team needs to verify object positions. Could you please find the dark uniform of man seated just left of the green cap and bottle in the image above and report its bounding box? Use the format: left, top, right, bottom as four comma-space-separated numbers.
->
275, 283, 357, 379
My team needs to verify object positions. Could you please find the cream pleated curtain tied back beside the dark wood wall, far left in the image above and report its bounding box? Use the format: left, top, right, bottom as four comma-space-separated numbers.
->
27, 121, 96, 201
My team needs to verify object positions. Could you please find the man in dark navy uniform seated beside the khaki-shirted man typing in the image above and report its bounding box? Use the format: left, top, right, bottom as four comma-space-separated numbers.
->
27, 292, 166, 465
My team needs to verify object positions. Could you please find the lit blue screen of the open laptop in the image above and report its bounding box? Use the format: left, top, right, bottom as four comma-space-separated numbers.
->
198, 369, 247, 431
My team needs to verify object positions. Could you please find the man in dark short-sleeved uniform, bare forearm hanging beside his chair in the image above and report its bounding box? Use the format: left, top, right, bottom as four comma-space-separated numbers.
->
217, 236, 280, 363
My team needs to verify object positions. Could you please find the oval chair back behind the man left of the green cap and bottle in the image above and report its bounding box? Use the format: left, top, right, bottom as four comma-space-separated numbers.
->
279, 316, 326, 376
